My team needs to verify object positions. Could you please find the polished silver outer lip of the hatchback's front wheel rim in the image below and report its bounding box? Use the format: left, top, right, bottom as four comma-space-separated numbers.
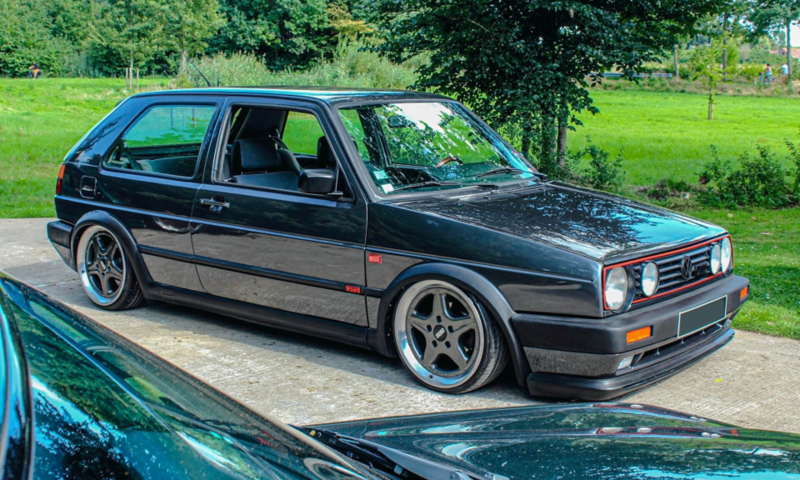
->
393, 280, 485, 389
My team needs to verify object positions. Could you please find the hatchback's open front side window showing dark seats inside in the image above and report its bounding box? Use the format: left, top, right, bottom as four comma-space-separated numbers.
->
215, 106, 348, 196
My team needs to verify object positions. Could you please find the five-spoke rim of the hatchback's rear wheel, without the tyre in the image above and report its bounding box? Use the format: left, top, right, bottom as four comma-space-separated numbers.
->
76, 225, 128, 306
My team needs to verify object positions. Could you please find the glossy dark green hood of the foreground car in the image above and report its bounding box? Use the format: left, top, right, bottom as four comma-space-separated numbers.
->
320, 404, 800, 479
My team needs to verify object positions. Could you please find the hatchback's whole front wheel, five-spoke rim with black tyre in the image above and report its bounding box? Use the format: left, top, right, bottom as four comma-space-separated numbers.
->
393, 280, 508, 393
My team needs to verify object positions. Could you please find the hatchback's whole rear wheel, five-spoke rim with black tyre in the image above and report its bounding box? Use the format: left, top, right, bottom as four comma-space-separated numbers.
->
75, 225, 144, 310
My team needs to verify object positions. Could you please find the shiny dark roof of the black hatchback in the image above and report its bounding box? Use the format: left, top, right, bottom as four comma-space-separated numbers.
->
136, 85, 450, 103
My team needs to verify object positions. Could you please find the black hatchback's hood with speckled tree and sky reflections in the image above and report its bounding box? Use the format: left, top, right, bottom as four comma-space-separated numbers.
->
402, 183, 725, 260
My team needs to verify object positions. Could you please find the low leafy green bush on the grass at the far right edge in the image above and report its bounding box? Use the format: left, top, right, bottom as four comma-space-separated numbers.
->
699, 146, 794, 208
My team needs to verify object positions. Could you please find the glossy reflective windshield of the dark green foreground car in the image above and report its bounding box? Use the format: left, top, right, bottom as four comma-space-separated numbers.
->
0, 278, 374, 479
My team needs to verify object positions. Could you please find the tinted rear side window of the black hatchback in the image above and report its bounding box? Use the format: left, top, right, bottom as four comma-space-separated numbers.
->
105, 105, 215, 177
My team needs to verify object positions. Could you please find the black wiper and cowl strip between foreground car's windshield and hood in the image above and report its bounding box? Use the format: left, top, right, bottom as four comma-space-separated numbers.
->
294, 427, 481, 480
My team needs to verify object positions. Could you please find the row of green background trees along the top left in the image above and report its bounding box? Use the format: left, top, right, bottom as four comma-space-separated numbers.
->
0, 0, 374, 76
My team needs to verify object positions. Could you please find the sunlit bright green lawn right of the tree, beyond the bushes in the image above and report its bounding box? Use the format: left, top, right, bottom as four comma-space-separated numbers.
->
568, 90, 800, 185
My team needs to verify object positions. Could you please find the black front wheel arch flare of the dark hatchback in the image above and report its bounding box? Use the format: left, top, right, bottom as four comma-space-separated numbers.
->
368, 263, 530, 385
